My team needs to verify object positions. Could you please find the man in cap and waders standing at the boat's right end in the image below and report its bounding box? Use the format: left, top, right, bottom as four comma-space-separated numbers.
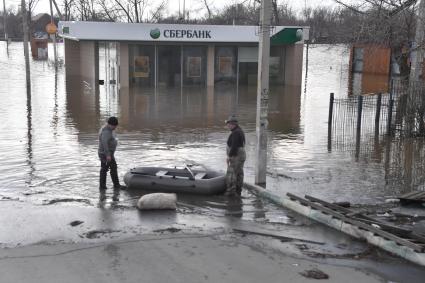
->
224, 116, 246, 196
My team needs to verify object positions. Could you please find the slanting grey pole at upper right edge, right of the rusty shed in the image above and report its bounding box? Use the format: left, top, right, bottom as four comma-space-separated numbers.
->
410, 0, 425, 82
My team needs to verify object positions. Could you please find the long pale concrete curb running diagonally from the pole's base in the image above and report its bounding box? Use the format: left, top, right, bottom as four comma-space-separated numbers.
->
244, 183, 425, 266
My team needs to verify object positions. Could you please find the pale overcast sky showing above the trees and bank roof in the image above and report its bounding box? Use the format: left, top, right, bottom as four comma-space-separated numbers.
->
4, 0, 355, 17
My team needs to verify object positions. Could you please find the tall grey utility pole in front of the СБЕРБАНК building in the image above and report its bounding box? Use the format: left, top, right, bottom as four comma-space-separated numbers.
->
255, 0, 271, 184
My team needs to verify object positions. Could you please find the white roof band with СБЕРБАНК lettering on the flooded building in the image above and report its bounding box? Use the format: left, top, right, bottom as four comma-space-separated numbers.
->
58, 21, 309, 43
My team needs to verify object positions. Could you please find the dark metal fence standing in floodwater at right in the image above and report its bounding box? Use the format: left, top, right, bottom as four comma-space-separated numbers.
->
329, 80, 425, 145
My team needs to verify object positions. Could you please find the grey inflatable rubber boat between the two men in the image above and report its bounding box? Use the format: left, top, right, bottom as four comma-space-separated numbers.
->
124, 167, 226, 195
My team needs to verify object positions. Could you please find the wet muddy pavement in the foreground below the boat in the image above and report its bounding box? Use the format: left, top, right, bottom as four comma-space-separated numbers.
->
0, 197, 425, 282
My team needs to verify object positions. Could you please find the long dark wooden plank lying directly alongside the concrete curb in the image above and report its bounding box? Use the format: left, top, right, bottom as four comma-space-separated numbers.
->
286, 193, 424, 252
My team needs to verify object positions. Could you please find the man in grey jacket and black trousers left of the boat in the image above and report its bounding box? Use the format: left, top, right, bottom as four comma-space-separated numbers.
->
98, 117, 122, 201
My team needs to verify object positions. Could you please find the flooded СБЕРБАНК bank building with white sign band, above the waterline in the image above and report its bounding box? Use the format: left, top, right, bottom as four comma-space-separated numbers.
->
59, 22, 309, 88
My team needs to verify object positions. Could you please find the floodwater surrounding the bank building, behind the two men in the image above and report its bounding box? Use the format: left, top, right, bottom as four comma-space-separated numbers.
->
0, 43, 420, 213
